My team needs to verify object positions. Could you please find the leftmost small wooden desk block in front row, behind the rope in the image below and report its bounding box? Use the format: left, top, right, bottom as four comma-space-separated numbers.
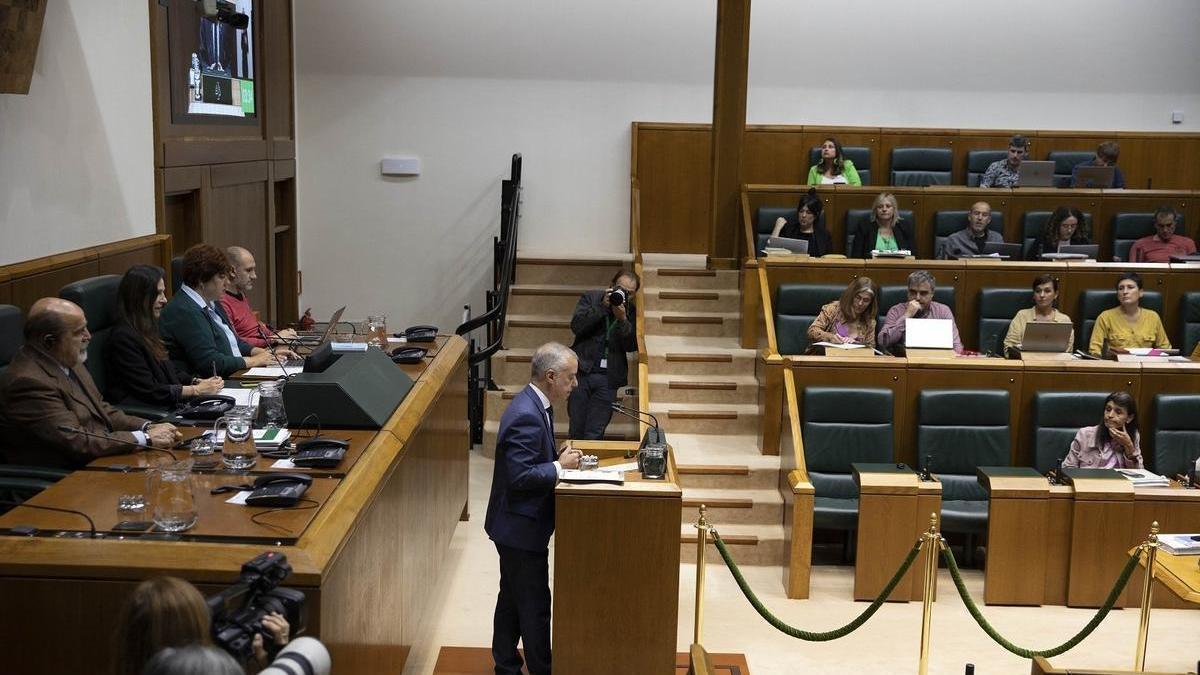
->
852, 462, 942, 602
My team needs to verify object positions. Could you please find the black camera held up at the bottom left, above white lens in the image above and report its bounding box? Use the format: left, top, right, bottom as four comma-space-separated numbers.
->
205, 551, 305, 661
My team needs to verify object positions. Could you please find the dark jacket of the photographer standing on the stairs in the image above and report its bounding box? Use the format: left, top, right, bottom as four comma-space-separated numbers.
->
571, 291, 637, 388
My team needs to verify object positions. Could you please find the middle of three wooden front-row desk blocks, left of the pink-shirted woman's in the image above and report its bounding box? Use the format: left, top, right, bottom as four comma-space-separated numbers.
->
978, 466, 1050, 605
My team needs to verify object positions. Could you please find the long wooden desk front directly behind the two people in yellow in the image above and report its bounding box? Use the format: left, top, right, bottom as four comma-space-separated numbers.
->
742, 258, 1200, 348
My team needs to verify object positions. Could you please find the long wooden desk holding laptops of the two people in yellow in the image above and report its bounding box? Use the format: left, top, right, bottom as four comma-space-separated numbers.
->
761, 357, 1200, 466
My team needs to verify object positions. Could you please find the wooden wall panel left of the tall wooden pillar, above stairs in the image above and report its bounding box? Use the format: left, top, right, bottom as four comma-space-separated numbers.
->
635, 127, 712, 253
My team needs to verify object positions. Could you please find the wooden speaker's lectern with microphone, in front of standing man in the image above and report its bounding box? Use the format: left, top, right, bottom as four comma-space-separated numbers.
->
553, 441, 683, 675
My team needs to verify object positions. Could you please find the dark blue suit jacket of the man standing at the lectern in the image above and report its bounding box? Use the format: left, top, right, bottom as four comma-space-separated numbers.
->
484, 386, 558, 551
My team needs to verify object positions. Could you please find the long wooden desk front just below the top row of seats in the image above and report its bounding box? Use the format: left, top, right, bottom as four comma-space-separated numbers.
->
740, 185, 1200, 261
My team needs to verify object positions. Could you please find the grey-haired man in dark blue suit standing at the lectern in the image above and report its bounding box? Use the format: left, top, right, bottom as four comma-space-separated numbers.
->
484, 342, 581, 675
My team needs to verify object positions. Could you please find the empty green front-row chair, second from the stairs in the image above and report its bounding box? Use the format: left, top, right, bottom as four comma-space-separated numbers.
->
917, 389, 1010, 558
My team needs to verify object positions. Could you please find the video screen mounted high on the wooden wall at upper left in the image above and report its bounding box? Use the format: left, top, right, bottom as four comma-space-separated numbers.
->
187, 0, 254, 118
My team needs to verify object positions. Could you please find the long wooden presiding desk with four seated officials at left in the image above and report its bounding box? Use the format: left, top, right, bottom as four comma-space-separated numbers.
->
0, 336, 470, 674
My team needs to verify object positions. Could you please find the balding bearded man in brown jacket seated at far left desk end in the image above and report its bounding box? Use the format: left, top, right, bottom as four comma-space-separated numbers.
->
0, 298, 179, 468
